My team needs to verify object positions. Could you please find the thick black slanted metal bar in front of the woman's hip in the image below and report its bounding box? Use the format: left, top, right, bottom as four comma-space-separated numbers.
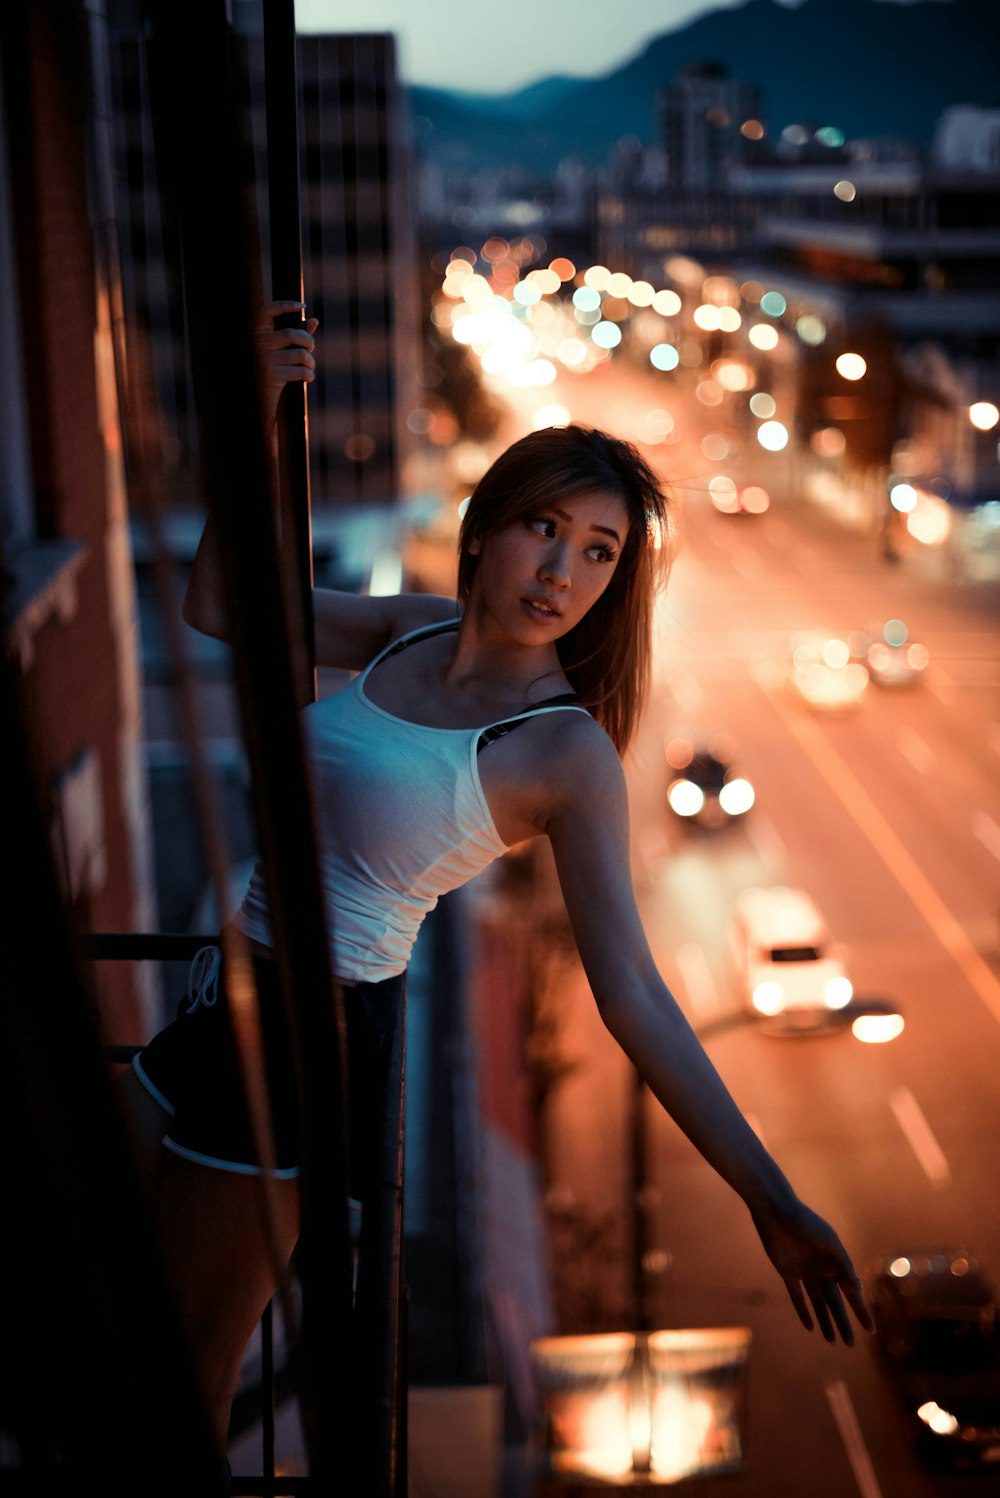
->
145, 0, 352, 1477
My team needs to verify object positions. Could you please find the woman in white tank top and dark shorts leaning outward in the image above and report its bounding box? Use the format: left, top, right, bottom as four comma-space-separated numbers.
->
117, 304, 870, 1447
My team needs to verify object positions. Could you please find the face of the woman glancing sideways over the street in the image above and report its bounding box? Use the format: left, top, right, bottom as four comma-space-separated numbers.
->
467, 490, 629, 646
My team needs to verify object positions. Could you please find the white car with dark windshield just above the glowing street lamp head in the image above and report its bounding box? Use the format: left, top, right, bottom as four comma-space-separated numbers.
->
731, 884, 853, 1035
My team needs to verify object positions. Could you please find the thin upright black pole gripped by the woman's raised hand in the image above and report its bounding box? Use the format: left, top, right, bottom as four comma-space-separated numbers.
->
263, 0, 316, 703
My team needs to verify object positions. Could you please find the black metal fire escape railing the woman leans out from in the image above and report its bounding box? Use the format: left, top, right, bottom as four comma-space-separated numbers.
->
82, 0, 406, 1498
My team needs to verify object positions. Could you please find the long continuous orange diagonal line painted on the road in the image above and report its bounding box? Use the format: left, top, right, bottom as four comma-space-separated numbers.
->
757, 694, 1000, 1020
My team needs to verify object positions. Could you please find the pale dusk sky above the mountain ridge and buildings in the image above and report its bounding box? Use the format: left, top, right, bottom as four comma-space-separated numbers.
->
295, 0, 934, 93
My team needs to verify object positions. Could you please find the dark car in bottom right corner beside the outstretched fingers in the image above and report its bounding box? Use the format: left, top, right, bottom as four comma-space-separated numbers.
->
865, 1246, 1000, 1479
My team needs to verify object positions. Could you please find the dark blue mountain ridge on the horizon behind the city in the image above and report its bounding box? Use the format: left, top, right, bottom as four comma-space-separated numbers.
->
409, 0, 1000, 175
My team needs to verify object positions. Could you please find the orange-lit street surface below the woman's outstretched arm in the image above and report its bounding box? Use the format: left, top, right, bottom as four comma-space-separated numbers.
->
514, 370, 1000, 1498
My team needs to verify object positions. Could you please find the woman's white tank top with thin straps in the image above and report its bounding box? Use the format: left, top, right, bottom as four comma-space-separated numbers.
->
237, 620, 587, 983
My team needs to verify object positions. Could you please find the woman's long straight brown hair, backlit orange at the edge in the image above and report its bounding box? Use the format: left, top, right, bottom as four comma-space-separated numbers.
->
458, 425, 674, 753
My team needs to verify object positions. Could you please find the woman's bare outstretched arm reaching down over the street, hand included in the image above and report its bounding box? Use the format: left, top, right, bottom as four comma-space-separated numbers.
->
545, 724, 871, 1344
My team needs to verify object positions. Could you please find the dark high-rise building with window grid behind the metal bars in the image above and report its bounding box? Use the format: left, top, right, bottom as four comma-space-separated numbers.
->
112, 20, 421, 511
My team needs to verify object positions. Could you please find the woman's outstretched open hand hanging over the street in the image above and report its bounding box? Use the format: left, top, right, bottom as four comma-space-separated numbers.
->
750, 1201, 873, 1347
